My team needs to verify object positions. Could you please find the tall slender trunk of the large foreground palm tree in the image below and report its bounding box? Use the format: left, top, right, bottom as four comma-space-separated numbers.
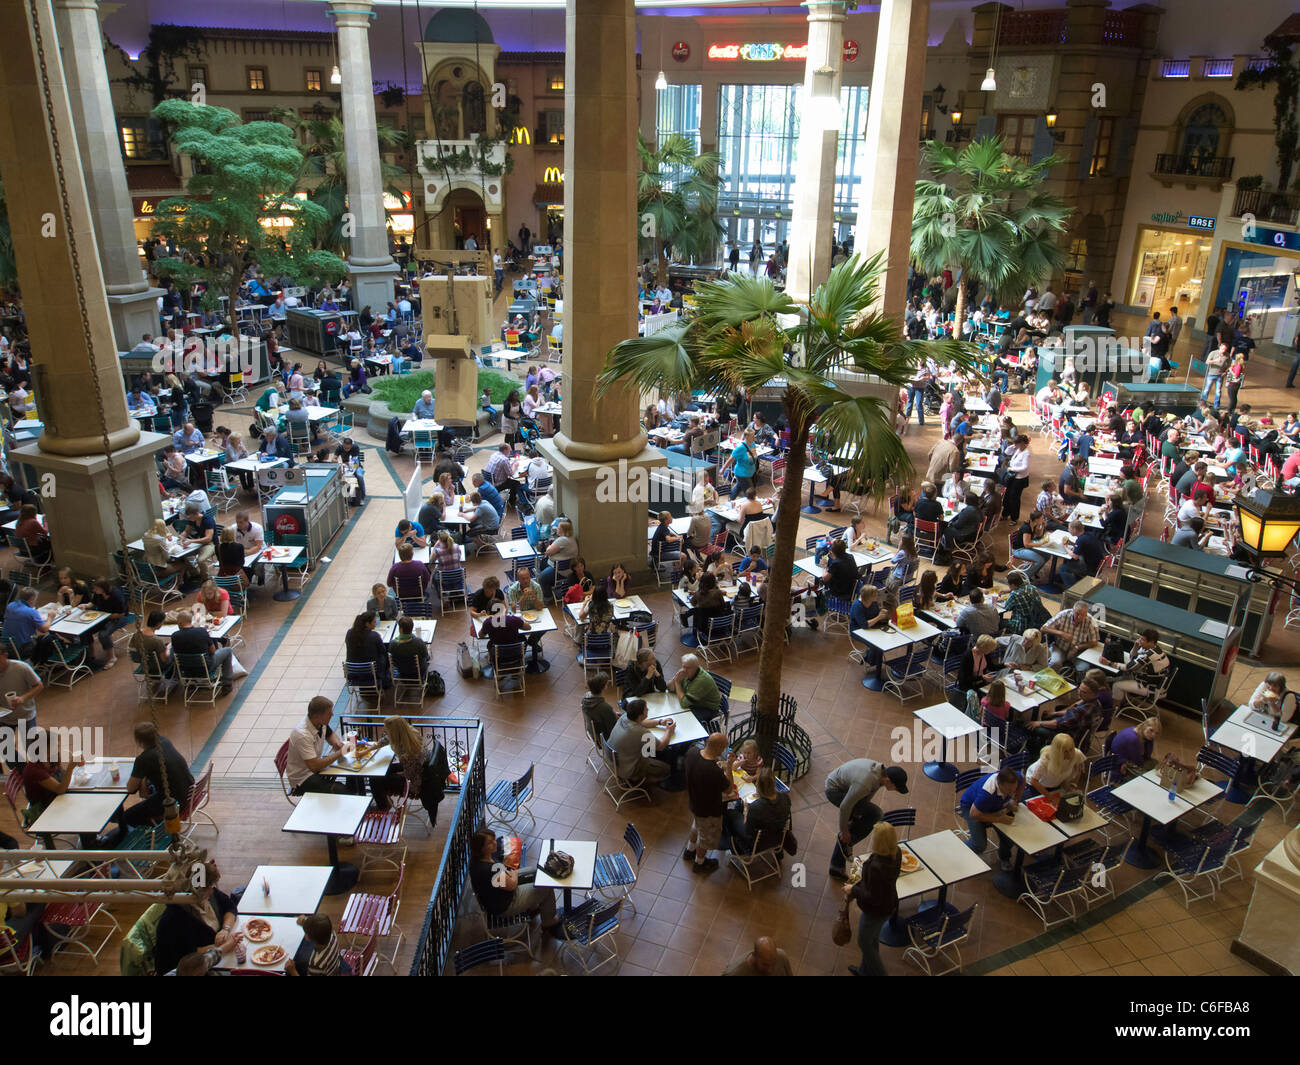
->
754, 407, 809, 758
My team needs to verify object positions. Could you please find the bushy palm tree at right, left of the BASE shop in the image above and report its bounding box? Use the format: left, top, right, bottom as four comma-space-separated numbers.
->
911, 137, 1073, 337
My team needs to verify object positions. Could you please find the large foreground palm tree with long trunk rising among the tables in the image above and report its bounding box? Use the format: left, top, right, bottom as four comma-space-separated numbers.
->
598, 255, 978, 746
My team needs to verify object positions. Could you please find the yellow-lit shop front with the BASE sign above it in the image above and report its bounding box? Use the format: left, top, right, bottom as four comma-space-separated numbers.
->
1122, 211, 1217, 312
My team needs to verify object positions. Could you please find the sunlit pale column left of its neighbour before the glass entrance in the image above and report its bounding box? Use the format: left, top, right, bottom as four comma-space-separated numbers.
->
785, 0, 847, 303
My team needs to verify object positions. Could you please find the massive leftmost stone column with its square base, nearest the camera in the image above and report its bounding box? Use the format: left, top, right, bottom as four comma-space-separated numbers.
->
0, 0, 166, 573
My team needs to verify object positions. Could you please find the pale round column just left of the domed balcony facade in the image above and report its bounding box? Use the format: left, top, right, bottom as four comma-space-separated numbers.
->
329, 0, 398, 311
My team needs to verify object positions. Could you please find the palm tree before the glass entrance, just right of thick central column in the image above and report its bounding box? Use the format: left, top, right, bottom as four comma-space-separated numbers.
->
637, 133, 723, 285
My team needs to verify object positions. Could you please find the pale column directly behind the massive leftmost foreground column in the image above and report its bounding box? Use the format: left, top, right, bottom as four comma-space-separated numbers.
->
55, 0, 163, 351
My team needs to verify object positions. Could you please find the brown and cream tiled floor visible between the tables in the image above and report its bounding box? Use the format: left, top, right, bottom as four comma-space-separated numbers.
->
10, 312, 1297, 975
